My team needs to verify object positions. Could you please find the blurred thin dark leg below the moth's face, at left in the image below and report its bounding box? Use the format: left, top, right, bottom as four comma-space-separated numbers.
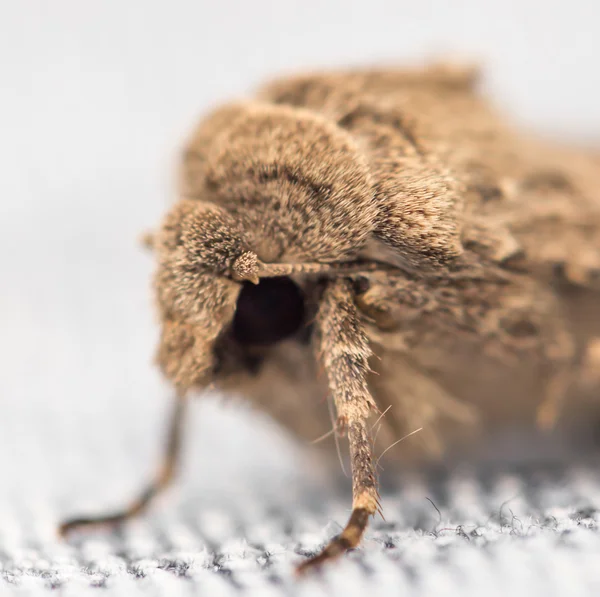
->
59, 397, 187, 537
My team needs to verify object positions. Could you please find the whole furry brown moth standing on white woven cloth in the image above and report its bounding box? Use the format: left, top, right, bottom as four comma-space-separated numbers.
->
61, 64, 600, 571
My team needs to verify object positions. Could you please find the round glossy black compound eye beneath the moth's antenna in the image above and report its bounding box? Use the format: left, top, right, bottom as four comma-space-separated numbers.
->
233, 277, 305, 346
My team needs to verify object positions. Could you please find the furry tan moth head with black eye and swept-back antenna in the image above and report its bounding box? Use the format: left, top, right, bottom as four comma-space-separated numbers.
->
154, 200, 382, 390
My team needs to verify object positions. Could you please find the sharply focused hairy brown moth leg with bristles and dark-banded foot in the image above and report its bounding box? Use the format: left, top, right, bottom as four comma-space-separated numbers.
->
298, 279, 379, 572
